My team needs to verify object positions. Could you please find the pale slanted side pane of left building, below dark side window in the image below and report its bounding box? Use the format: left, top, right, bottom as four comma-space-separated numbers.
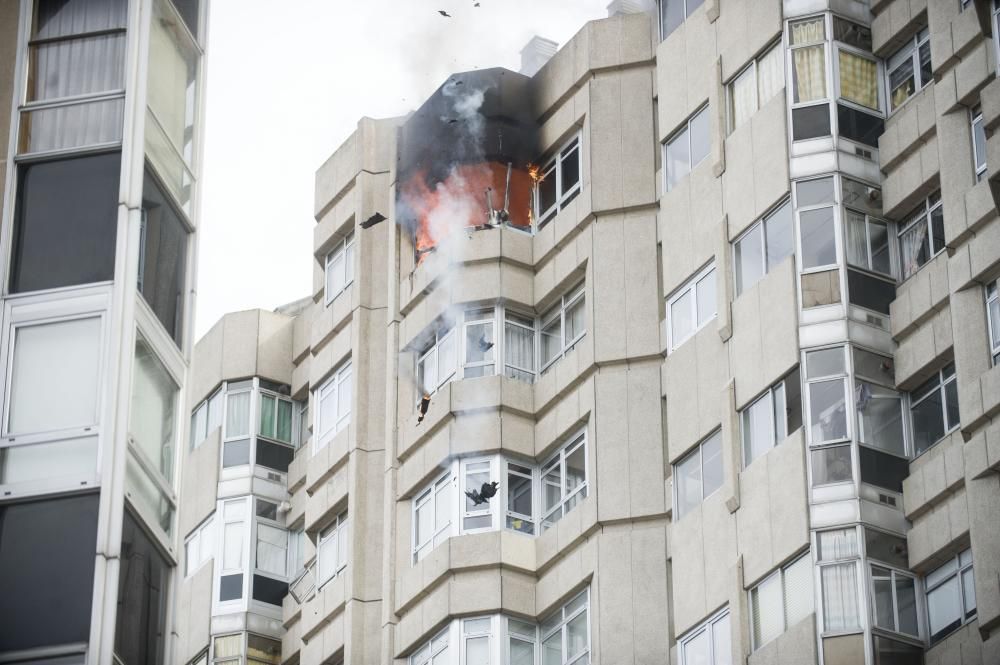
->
129, 337, 178, 482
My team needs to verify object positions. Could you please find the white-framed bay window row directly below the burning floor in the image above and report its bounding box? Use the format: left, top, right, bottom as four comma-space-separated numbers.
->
417, 282, 586, 395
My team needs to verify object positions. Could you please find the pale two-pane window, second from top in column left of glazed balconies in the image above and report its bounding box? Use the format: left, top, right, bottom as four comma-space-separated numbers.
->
733, 200, 795, 295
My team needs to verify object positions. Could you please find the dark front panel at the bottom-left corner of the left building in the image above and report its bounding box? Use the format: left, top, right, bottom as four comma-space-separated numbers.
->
0, 494, 98, 651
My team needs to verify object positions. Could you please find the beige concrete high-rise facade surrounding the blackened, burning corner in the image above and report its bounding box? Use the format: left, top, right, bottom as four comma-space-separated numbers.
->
177, 0, 1000, 665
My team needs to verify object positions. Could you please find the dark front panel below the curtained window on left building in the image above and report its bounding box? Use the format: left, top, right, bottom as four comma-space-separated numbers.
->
10, 152, 121, 293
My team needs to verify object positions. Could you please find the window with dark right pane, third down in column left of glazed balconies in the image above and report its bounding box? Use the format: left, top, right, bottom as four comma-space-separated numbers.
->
740, 369, 802, 466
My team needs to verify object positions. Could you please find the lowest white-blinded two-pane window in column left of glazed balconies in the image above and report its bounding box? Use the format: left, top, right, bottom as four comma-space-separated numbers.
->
750, 552, 813, 651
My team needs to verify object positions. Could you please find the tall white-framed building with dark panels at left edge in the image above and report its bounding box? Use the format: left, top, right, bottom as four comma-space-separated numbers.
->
0, 0, 208, 665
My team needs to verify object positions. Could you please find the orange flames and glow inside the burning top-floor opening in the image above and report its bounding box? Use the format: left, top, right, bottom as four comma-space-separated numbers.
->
400, 162, 539, 263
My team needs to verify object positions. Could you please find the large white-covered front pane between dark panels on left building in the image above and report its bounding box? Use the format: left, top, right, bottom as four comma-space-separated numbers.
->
7, 317, 101, 434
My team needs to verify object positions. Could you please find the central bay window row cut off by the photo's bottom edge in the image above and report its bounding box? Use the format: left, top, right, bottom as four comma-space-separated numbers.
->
409, 589, 590, 665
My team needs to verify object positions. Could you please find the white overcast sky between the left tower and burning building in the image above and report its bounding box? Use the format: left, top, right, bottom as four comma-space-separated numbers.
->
195, 0, 609, 338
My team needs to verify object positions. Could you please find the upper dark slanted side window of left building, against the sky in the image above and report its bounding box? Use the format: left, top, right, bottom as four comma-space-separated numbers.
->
138, 170, 188, 346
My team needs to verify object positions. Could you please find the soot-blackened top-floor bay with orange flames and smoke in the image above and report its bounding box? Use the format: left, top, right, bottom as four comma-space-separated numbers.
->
396, 68, 537, 262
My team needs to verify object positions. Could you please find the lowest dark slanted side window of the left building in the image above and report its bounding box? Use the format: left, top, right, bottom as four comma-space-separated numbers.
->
115, 512, 170, 665
